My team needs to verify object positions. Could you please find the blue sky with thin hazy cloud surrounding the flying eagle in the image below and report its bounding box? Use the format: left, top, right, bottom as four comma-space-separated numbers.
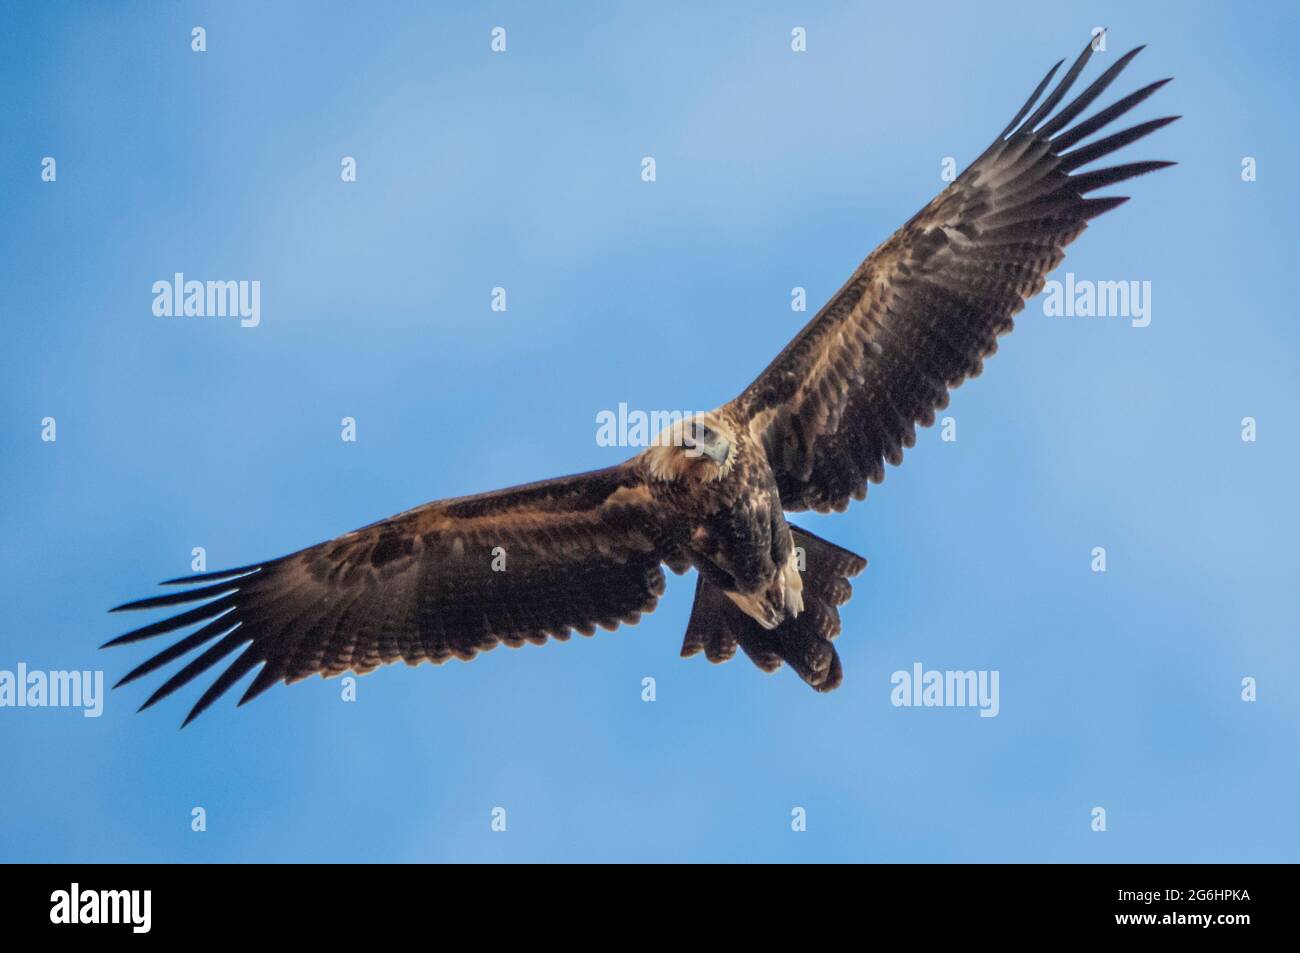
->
0, 3, 1300, 862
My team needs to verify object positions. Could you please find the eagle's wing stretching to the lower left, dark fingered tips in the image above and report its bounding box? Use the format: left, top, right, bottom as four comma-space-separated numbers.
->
105, 465, 684, 724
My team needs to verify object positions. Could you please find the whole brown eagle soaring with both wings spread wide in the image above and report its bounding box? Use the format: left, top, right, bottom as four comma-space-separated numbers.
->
104, 40, 1178, 727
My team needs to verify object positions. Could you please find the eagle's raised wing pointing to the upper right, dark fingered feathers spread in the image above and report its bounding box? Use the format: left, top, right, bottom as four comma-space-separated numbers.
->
732, 44, 1178, 512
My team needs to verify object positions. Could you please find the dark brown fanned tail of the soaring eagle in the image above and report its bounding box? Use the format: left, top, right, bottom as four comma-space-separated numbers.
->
681, 525, 867, 692
